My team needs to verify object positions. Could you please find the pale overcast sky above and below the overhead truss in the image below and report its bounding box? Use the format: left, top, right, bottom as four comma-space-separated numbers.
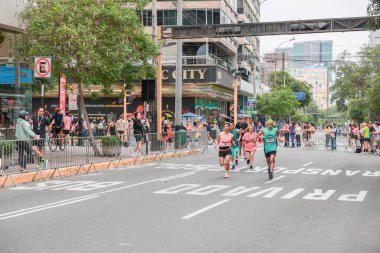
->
261, 0, 369, 59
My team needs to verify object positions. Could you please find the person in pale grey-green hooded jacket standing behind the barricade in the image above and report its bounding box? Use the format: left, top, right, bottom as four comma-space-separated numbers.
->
15, 110, 42, 172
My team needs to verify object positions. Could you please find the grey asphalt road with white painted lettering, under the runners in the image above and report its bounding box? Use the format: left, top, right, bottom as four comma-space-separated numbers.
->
0, 148, 380, 253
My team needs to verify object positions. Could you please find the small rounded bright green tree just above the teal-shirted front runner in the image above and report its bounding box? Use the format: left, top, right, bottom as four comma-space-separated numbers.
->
257, 87, 300, 119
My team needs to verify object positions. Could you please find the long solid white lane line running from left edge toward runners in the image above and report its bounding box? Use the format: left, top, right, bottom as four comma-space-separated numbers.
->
0, 172, 196, 220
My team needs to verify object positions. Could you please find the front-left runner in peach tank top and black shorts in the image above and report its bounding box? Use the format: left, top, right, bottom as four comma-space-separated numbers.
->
216, 123, 234, 178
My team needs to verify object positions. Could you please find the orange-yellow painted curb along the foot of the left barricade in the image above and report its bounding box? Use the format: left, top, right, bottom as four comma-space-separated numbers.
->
0, 149, 202, 188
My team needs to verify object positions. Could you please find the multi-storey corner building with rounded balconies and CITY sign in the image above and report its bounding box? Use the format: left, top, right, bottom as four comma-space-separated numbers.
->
134, 0, 260, 120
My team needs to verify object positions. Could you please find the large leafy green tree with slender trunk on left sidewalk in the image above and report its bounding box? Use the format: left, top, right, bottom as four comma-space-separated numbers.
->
21, 0, 158, 154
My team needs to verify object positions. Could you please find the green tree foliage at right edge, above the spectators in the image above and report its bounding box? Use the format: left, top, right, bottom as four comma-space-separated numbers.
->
331, 45, 380, 121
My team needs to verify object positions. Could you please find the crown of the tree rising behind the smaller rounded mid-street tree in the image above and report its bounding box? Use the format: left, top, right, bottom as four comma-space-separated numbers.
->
269, 71, 312, 107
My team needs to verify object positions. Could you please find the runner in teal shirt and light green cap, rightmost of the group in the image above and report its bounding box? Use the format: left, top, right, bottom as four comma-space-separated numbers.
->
259, 119, 280, 180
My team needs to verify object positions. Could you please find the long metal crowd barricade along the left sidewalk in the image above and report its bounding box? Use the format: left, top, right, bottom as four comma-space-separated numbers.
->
0, 131, 208, 186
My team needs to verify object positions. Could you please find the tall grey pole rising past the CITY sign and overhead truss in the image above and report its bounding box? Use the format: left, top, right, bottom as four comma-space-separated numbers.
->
175, 0, 182, 131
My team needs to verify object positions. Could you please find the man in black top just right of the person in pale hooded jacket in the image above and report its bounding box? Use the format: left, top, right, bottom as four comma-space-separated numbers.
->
32, 108, 50, 155
